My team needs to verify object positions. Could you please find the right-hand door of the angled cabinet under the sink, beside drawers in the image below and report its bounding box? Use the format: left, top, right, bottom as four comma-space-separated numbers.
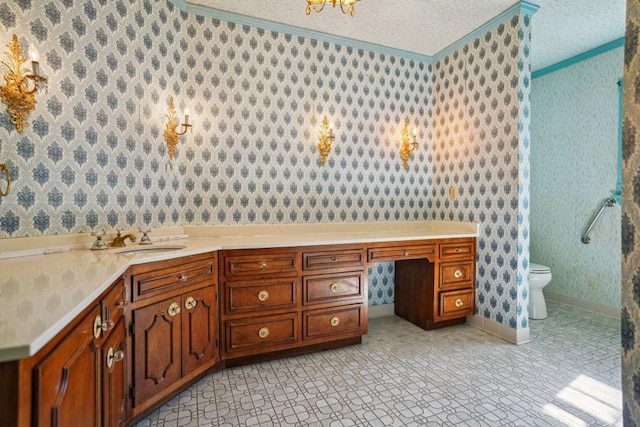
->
182, 287, 218, 376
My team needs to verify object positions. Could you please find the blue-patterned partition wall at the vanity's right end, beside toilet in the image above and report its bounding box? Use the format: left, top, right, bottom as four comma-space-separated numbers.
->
431, 15, 531, 329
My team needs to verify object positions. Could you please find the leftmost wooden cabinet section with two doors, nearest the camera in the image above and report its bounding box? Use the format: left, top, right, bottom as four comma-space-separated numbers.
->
7, 278, 126, 426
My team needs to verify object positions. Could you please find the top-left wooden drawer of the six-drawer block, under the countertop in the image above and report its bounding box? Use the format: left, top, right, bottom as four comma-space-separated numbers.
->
224, 252, 298, 277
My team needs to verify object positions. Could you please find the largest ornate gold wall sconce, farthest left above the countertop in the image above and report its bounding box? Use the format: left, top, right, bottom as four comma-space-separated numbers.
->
0, 34, 47, 133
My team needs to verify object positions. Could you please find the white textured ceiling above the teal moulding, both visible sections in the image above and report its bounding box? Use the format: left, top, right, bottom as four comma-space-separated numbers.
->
187, 0, 625, 71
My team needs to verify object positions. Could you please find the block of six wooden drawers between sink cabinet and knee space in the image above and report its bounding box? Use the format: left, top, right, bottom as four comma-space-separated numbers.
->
220, 246, 367, 360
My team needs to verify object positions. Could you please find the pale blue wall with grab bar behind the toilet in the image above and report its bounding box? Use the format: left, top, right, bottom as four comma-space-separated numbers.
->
531, 48, 624, 308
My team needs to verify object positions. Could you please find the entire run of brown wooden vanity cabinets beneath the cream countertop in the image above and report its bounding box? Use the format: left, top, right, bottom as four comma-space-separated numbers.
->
0, 234, 476, 427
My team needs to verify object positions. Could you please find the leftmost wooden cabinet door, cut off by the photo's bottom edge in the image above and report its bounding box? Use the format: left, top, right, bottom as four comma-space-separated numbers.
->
33, 306, 100, 427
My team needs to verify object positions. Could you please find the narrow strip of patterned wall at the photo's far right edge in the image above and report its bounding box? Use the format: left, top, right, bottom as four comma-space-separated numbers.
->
621, 0, 640, 427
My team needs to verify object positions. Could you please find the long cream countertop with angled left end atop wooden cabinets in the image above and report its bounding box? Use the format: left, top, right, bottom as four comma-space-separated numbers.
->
0, 222, 478, 362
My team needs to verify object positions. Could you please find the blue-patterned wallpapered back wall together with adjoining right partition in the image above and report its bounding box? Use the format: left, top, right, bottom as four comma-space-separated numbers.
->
0, 0, 530, 328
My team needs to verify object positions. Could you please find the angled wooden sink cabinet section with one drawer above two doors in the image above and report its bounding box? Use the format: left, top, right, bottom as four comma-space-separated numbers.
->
127, 253, 219, 417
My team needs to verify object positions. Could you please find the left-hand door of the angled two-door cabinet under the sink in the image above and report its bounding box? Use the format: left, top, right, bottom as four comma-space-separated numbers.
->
132, 297, 182, 407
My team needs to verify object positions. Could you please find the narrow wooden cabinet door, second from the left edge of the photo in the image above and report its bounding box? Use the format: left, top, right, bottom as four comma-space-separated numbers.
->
102, 317, 127, 427
